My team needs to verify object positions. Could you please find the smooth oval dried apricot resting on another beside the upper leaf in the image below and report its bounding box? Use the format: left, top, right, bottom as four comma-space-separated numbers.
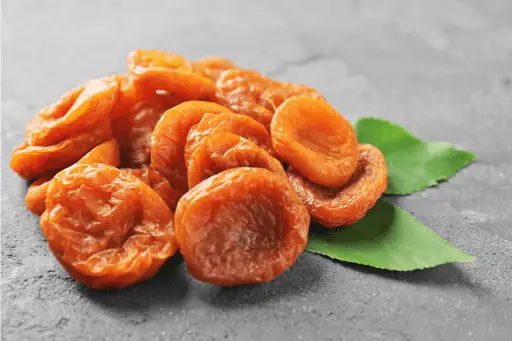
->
270, 96, 358, 187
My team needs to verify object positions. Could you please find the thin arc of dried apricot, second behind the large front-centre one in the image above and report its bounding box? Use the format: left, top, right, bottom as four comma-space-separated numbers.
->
185, 114, 273, 161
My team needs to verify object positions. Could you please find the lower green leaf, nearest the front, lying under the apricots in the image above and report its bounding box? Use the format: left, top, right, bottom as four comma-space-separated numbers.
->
307, 200, 476, 271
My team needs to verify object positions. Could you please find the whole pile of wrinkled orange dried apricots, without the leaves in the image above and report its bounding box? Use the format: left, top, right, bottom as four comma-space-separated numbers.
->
11, 50, 387, 289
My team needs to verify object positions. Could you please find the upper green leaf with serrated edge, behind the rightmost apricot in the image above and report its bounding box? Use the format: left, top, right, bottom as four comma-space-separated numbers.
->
354, 117, 475, 195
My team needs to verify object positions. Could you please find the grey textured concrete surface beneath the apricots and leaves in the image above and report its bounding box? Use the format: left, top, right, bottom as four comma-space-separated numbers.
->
1, 0, 512, 340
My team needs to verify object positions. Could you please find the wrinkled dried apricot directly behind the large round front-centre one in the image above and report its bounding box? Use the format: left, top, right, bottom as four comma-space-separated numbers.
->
187, 134, 287, 188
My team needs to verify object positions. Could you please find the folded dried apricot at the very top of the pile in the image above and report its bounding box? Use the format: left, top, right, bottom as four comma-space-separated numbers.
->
128, 50, 216, 101
